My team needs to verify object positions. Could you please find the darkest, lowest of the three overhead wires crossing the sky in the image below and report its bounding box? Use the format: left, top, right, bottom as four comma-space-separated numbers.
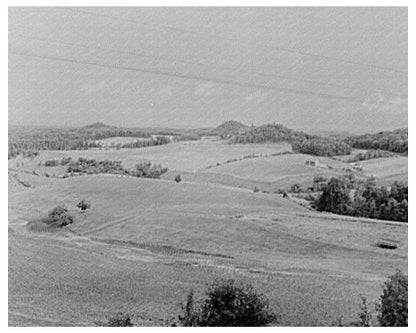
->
9, 51, 374, 103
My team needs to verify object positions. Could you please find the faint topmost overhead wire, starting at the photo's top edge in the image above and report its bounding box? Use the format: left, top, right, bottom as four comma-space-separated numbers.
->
61, 7, 407, 75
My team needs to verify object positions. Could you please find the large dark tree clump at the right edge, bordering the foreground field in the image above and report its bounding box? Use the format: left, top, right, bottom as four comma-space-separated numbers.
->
315, 174, 408, 222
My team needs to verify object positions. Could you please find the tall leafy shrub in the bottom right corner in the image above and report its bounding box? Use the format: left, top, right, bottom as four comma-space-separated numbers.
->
377, 271, 408, 327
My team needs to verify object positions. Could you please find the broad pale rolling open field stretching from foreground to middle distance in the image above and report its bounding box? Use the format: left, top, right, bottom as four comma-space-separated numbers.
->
9, 142, 408, 326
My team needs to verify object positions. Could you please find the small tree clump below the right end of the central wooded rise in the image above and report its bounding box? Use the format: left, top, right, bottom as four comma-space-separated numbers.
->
292, 138, 352, 156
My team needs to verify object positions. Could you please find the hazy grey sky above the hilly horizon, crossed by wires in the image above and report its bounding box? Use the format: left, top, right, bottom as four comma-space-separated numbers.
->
9, 7, 408, 132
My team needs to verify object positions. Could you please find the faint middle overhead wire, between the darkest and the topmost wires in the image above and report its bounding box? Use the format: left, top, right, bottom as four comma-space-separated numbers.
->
10, 33, 402, 97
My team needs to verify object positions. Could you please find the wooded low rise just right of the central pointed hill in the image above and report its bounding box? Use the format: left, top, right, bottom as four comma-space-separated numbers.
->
230, 124, 315, 143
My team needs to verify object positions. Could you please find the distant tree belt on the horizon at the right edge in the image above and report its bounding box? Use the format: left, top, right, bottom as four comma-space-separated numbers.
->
346, 128, 408, 153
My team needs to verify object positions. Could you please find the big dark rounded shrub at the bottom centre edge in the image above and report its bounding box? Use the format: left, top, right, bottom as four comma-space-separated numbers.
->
179, 280, 277, 327
